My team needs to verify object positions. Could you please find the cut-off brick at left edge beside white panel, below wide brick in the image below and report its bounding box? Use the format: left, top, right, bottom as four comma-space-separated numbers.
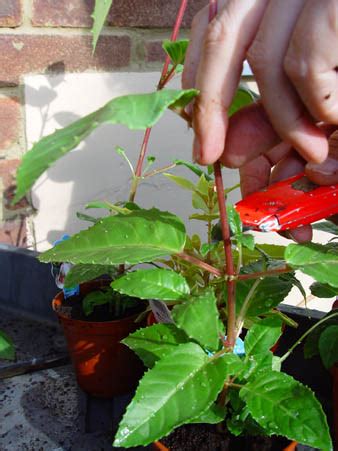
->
0, 97, 21, 153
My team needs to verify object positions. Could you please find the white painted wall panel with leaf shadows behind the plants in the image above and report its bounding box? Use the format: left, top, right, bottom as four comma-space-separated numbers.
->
25, 72, 332, 310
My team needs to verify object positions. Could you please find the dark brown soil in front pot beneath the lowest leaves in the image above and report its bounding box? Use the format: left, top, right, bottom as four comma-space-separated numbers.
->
160, 424, 290, 451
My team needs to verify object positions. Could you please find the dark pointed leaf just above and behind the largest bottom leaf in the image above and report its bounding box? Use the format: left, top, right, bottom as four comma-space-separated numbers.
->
122, 324, 189, 368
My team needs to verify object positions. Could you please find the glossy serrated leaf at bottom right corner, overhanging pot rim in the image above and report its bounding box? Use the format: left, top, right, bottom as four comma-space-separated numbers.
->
240, 371, 332, 451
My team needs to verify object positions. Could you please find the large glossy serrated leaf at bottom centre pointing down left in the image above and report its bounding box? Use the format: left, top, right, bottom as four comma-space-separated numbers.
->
114, 343, 241, 448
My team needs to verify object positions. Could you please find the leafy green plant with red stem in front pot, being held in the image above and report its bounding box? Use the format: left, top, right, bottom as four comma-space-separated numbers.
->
11, 1, 338, 450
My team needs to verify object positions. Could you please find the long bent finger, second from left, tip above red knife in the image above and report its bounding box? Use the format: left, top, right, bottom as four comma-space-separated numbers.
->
248, 0, 328, 163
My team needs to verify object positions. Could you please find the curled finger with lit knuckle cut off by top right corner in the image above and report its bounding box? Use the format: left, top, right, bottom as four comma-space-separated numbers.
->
284, 0, 338, 124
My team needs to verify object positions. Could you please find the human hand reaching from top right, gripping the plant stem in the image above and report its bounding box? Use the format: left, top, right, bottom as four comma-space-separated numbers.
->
183, 0, 338, 240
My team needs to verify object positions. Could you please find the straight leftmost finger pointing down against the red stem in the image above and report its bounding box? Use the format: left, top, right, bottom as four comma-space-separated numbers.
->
190, 0, 268, 164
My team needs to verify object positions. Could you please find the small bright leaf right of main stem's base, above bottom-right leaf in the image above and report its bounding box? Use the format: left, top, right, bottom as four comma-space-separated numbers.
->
244, 317, 282, 356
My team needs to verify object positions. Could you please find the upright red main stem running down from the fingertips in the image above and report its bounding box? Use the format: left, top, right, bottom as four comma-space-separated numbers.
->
214, 162, 236, 349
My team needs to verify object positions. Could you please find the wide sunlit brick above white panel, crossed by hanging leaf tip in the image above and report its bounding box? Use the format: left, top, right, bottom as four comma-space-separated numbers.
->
0, 34, 130, 86
